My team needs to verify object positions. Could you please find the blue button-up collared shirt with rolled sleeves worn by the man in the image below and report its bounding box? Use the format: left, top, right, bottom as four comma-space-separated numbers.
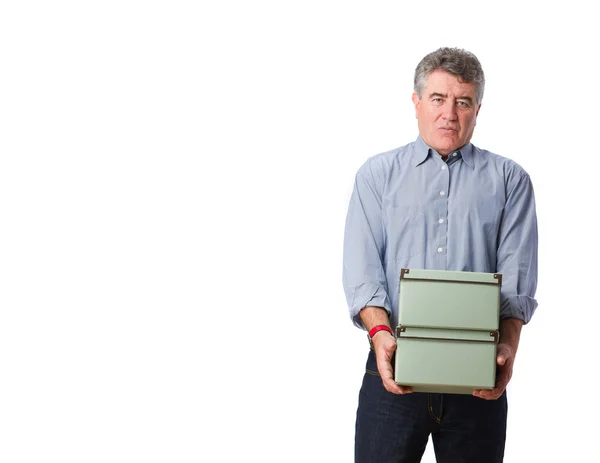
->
343, 137, 538, 328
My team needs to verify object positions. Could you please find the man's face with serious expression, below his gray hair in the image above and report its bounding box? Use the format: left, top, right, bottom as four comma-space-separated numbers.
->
412, 71, 481, 155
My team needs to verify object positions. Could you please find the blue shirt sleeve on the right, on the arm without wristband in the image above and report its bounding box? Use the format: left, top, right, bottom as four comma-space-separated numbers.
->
497, 173, 538, 323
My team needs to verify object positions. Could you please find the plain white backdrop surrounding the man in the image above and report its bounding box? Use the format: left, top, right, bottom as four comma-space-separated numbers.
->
0, 0, 600, 463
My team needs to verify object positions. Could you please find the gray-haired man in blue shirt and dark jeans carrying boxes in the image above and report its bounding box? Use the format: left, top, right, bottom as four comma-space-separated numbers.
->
343, 48, 537, 463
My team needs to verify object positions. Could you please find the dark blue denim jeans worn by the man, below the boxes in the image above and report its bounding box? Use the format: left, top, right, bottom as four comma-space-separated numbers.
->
355, 351, 507, 463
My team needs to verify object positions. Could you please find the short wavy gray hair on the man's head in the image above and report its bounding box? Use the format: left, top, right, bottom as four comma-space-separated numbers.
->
415, 47, 485, 104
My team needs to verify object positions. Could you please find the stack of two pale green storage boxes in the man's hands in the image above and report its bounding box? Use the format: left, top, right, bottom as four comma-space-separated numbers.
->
394, 269, 502, 394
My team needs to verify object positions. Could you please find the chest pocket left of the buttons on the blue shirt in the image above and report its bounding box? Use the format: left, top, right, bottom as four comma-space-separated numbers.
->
387, 205, 426, 259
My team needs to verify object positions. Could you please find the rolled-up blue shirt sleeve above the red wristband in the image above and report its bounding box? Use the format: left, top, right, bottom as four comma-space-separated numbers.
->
342, 164, 391, 328
